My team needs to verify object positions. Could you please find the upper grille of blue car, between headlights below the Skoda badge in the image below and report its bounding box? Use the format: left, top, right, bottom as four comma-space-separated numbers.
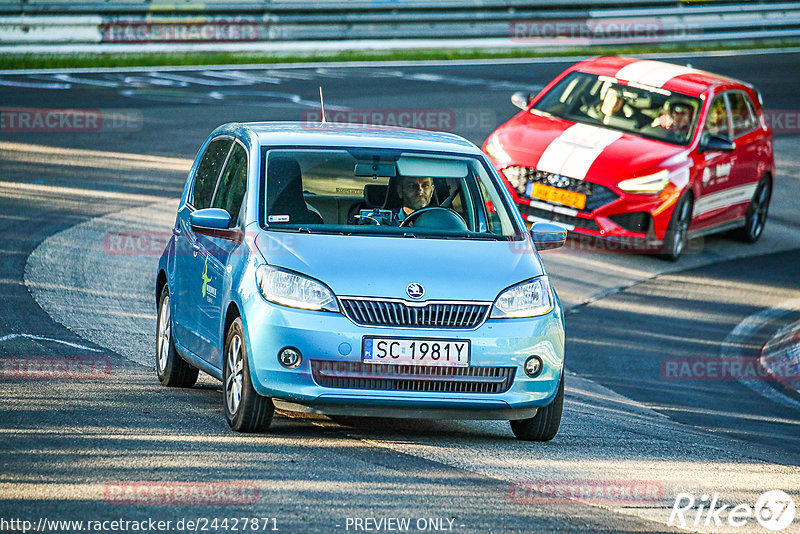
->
339, 297, 491, 329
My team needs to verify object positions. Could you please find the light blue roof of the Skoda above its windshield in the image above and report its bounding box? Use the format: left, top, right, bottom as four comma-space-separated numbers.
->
215, 122, 481, 154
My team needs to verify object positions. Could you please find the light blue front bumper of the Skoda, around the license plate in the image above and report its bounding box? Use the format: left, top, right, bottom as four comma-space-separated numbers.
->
242, 298, 564, 419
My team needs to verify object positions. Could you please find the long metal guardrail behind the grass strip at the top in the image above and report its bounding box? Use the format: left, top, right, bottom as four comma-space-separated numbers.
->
0, 0, 800, 52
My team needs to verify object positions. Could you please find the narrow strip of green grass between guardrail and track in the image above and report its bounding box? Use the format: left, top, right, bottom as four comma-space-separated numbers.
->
0, 39, 800, 69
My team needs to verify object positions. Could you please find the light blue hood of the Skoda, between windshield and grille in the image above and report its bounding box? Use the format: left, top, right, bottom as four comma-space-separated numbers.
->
256, 232, 543, 301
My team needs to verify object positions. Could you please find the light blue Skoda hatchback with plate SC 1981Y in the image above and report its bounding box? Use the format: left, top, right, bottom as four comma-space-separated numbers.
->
156, 123, 566, 441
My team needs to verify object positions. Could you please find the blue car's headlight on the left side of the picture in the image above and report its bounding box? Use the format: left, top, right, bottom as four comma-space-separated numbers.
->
256, 265, 339, 312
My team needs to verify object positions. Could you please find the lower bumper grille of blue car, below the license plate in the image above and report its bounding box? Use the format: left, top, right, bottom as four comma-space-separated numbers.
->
311, 360, 515, 393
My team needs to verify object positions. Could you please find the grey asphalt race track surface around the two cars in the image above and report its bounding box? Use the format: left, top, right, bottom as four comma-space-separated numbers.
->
0, 52, 800, 532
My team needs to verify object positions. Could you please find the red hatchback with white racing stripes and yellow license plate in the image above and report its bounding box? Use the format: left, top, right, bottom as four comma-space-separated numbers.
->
483, 57, 775, 261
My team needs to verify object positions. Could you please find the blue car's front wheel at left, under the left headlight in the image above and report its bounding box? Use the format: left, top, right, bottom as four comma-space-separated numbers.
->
222, 317, 275, 432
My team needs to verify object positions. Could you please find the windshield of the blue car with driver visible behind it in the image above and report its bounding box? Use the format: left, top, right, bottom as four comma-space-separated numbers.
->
262, 148, 522, 239
